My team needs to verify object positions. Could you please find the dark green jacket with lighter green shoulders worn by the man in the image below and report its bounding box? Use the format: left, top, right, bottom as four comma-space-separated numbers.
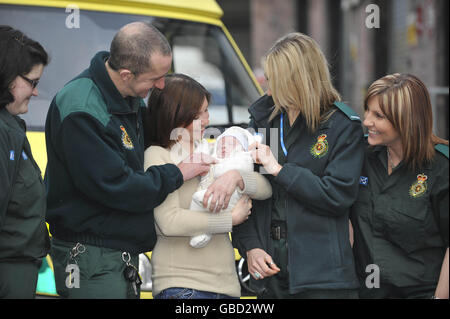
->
45, 52, 183, 253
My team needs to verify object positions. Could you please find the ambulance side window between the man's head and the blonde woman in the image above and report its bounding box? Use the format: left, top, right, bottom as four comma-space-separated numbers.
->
170, 22, 259, 126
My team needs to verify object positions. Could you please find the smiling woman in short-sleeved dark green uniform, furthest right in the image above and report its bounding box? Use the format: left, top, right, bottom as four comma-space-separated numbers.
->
351, 74, 449, 298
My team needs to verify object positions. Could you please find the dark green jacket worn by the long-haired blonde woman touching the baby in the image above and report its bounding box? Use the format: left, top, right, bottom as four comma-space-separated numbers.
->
233, 95, 364, 294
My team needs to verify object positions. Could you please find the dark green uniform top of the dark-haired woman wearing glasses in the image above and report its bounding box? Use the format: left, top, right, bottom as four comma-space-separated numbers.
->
0, 108, 49, 262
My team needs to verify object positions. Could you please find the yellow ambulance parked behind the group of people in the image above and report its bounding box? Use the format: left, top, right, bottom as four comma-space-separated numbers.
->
0, 0, 262, 298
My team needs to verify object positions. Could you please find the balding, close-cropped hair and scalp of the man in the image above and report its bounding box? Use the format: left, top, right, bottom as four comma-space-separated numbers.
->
108, 22, 172, 75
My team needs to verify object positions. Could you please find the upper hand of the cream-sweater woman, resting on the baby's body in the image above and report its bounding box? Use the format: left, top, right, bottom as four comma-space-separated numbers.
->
203, 170, 244, 212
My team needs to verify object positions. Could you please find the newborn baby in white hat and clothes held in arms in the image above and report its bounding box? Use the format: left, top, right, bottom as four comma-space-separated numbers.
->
190, 126, 257, 248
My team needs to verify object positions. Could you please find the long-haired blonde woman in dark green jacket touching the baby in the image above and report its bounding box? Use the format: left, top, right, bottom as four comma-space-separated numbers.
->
233, 33, 364, 298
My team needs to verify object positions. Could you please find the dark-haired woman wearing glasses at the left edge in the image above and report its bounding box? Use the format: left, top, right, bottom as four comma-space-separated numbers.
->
0, 26, 49, 298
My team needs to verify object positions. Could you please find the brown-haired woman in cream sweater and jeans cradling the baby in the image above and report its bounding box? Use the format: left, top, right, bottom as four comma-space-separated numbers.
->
144, 74, 272, 299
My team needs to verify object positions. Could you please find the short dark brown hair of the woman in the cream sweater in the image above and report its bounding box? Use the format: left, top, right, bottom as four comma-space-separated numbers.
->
145, 74, 211, 148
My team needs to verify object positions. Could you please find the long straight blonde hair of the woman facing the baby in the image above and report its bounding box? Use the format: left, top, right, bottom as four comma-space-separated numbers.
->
264, 32, 341, 132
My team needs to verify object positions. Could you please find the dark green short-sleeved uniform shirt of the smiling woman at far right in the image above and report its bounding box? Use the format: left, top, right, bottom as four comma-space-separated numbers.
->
351, 146, 449, 297
